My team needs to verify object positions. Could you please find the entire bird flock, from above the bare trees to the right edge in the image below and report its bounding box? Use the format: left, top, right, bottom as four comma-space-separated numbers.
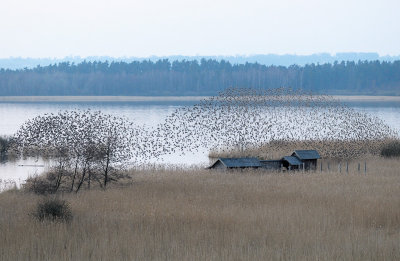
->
13, 88, 397, 165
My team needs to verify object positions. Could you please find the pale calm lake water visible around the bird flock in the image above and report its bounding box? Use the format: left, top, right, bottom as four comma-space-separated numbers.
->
0, 98, 400, 186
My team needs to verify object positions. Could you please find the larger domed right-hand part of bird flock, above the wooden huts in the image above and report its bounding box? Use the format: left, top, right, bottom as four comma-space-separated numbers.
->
145, 88, 396, 160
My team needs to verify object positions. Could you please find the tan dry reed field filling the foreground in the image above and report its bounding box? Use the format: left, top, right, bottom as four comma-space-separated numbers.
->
0, 155, 400, 260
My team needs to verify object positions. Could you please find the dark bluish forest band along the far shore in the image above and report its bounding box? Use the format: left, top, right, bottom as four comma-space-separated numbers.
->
0, 59, 400, 96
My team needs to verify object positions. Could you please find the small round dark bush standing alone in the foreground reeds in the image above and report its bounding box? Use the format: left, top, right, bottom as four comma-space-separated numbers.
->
32, 198, 72, 222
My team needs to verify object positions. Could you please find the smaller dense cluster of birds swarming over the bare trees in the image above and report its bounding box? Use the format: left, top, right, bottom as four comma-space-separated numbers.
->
14, 110, 145, 164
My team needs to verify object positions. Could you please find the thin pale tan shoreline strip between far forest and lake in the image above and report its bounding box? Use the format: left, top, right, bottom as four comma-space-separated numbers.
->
0, 95, 400, 102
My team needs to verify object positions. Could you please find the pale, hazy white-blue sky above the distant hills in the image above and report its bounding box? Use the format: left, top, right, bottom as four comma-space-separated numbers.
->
0, 0, 400, 58
